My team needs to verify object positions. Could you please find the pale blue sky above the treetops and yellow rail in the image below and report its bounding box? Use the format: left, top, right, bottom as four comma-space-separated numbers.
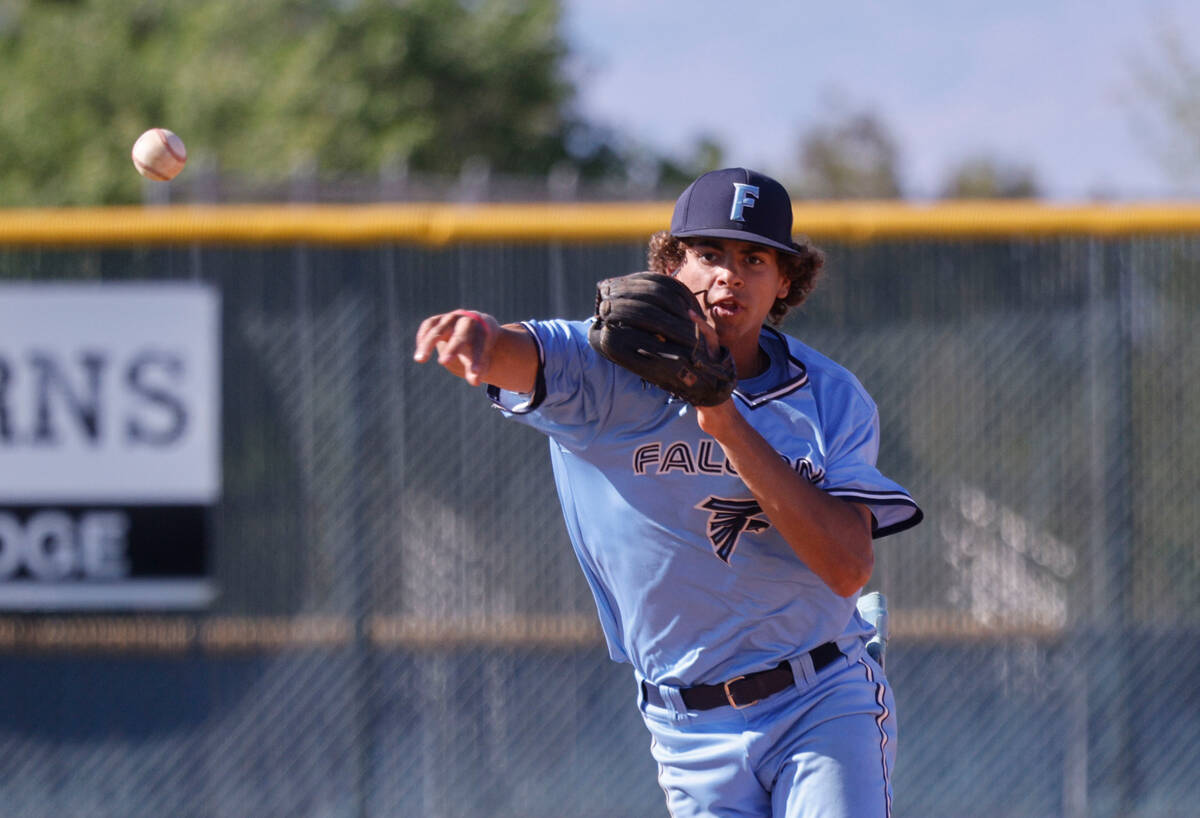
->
563, 0, 1200, 200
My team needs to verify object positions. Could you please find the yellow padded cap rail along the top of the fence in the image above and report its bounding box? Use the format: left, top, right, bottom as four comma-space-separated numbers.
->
7, 202, 1200, 247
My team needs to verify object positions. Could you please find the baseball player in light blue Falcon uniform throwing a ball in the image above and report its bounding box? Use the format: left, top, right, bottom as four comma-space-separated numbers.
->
414, 168, 922, 818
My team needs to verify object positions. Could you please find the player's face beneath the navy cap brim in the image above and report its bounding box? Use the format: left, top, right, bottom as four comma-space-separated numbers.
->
676, 239, 790, 354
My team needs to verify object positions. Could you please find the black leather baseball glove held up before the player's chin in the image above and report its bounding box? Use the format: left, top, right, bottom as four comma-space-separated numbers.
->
588, 272, 737, 407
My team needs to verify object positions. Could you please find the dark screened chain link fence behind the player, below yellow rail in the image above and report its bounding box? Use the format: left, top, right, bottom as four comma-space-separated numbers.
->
0, 218, 1200, 818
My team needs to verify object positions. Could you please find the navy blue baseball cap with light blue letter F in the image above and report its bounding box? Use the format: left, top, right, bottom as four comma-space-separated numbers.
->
671, 168, 800, 255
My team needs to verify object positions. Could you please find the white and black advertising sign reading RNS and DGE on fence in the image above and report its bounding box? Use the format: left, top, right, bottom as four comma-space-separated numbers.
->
0, 282, 221, 611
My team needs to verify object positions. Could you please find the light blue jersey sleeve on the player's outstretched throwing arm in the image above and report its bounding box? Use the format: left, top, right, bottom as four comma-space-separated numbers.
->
487, 319, 613, 447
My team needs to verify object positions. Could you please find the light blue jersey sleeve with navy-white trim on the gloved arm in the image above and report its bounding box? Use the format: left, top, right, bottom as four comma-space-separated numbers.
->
823, 371, 924, 539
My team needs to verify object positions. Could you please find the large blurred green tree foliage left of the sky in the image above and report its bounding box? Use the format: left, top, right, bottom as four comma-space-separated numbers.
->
0, 0, 622, 205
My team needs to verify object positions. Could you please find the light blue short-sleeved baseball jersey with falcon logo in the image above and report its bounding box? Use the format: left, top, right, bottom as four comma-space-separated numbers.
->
488, 320, 922, 686
